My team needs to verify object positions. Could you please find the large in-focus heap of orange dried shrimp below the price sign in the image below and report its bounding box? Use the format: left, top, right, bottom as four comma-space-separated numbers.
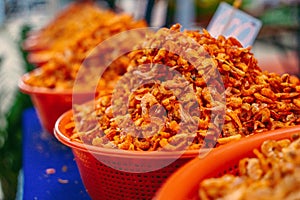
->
68, 24, 300, 151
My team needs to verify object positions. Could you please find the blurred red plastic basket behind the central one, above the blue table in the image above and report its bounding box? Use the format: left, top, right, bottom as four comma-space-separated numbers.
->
18, 68, 89, 135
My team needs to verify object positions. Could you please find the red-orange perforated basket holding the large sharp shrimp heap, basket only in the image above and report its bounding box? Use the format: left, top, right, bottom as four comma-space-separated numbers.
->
54, 110, 206, 200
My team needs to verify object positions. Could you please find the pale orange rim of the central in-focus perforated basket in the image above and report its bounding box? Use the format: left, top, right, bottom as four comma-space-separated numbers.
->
54, 109, 210, 160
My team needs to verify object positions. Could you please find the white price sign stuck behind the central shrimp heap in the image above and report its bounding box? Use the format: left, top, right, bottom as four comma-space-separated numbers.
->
207, 2, 262, 47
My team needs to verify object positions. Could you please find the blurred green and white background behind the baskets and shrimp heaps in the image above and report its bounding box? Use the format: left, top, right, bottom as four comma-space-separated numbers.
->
0, 0, 300, 199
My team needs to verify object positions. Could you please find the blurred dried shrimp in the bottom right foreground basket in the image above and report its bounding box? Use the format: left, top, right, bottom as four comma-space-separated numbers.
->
199, 134, 300, 200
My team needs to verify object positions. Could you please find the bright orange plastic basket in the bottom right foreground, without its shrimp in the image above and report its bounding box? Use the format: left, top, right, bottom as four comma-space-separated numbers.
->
154, 125, 300, 200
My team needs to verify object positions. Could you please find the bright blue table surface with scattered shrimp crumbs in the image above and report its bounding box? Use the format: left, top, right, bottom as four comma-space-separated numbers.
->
22, 108, 90, 200
